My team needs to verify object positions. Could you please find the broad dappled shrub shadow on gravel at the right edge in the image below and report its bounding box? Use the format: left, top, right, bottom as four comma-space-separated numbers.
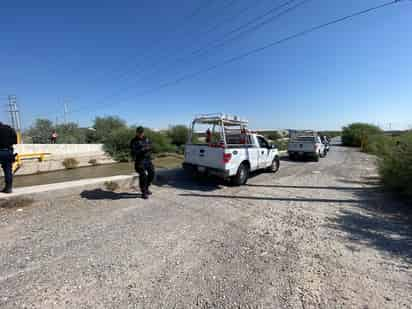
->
327, 183, 412, 264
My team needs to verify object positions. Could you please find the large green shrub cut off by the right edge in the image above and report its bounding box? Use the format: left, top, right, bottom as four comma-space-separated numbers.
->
379, 133, 412, 199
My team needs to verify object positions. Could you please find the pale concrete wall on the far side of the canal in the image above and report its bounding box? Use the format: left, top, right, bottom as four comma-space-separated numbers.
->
3, 144, 114, 175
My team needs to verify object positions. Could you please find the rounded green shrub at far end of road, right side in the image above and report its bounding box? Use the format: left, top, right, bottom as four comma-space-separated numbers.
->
342, 123, 382, 147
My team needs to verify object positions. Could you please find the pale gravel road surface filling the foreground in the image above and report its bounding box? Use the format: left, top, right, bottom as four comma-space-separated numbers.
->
0, 147, 412, 309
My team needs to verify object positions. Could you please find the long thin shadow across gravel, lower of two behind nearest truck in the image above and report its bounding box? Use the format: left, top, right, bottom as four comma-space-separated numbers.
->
180, 193, 362, 203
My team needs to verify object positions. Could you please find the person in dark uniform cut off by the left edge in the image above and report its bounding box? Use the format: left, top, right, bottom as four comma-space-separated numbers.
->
0, 122, 17, 193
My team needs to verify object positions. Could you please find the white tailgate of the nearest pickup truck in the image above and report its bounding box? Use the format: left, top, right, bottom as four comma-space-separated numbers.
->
185, 145, 225, 170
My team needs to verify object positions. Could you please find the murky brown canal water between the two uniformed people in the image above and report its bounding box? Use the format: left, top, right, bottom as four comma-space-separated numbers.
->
14, 163, 134, 187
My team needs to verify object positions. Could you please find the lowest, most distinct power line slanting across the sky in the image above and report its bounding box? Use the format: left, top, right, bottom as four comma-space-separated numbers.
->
55, 0, 405, 113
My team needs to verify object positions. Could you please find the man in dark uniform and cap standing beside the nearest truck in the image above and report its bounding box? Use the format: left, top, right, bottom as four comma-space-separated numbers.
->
130, 127, 155, 199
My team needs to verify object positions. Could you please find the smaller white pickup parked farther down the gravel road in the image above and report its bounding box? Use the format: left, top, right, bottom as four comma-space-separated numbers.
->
288, 133, 326, 161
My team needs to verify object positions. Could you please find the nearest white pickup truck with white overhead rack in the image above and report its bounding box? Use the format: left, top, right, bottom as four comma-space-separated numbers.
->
183, 114, 280, 185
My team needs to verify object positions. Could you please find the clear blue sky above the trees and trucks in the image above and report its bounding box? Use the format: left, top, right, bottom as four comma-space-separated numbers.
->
0, 0, 412, 129
